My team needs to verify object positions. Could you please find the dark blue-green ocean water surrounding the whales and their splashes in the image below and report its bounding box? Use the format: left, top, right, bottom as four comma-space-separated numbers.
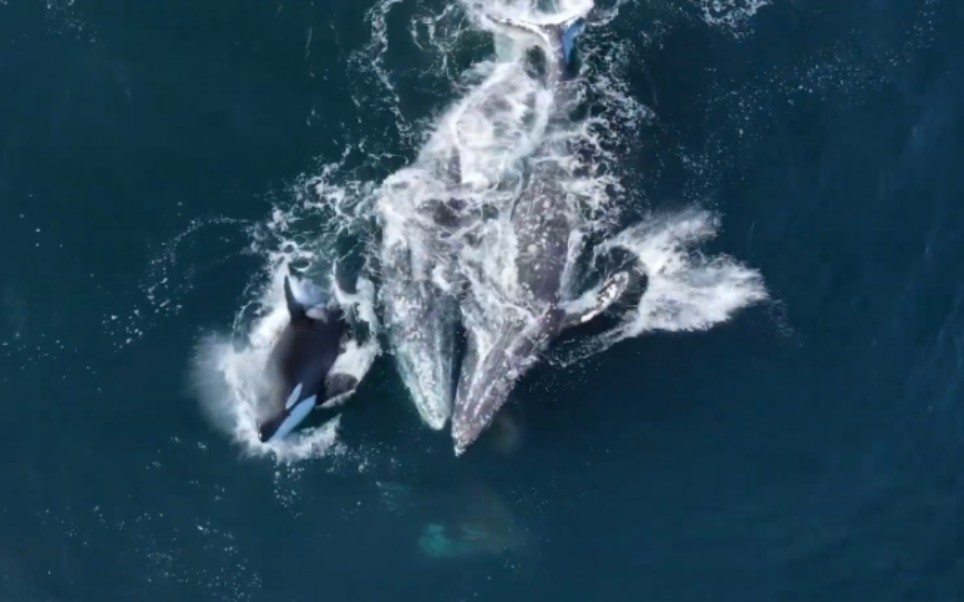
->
0, 0, 964, 602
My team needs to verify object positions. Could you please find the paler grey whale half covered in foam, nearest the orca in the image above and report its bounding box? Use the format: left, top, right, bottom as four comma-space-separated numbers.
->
376, 8, 572, 430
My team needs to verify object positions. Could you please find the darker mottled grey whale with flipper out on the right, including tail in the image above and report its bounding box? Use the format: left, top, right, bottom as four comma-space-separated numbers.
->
452, 11, 644, 454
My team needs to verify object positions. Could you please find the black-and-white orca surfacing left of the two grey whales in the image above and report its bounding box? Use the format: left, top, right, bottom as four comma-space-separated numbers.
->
258, 276, 368, 442
